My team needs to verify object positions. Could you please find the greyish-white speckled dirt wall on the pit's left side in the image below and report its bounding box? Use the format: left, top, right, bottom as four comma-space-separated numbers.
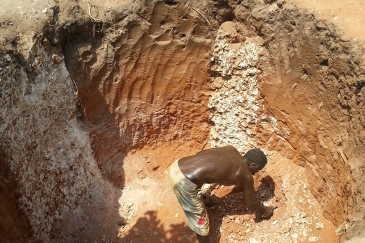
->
1, 32, 120, 242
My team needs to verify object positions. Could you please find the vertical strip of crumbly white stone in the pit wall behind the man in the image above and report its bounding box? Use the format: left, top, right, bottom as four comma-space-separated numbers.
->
208, 21, 262, 152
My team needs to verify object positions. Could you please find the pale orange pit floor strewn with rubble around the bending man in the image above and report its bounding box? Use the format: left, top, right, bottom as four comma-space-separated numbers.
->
116, 143, 338, 243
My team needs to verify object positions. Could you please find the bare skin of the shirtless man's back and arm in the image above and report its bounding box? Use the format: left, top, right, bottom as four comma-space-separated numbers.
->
179, 146, 275, 243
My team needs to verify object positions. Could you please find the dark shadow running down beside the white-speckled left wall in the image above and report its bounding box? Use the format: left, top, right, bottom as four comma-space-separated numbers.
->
59, 24, 128, 242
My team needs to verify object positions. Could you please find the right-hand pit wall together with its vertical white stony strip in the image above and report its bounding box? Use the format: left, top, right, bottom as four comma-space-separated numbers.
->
211, 1, 364, 238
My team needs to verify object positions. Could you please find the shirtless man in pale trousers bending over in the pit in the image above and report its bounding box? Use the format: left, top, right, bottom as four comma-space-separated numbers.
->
168, 145, 275, 243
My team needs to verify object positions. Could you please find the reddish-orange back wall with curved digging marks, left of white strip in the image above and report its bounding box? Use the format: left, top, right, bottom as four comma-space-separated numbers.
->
63, 2, 212, 187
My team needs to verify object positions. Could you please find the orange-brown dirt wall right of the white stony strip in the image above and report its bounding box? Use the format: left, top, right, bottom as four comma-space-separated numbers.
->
236, 2, 364, 239
